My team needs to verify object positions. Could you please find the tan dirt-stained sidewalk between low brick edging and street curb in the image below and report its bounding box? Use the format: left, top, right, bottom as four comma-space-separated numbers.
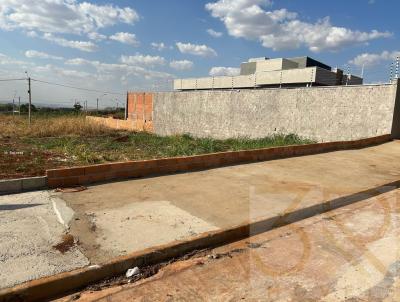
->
58, 141, 400, 263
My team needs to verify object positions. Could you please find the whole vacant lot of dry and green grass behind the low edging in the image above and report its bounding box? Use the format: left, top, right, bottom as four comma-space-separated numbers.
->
0, 115, 311, 178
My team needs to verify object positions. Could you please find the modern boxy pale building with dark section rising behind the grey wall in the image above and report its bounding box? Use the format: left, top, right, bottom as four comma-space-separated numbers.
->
174, 57, 363, 91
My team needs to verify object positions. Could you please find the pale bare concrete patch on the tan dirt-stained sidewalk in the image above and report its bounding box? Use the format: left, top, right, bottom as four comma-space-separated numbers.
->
89, 201, 217, 254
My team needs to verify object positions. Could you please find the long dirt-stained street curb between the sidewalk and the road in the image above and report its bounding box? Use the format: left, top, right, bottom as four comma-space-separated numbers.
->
0, 181, 400, 302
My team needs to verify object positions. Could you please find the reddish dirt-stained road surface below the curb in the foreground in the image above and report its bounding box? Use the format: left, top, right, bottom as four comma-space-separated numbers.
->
60, 185, 400, 302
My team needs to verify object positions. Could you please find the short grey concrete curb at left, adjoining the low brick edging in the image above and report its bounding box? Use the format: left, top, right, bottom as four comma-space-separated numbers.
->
0, 176, 47, 195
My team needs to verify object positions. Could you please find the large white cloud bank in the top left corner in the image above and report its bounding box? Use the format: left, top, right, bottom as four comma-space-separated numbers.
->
0, 0, 139, 34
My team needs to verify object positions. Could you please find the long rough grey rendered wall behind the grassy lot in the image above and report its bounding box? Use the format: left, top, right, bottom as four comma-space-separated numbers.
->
153, 83, 400, 142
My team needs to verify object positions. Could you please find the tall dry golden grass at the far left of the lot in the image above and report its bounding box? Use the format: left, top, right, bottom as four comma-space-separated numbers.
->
0, 115, 112, 138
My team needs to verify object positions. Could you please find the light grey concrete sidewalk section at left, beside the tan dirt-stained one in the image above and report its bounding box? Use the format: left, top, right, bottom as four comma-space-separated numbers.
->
0, 191, 89, 288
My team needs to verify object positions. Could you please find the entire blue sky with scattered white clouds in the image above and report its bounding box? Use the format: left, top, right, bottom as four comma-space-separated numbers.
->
0, 0, 400, 107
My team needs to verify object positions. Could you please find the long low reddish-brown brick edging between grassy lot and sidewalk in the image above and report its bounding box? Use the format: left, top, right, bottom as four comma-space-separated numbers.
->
46, 134, 391, 188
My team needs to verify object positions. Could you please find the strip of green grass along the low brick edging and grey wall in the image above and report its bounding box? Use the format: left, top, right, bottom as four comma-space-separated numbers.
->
23, 132, 310, 164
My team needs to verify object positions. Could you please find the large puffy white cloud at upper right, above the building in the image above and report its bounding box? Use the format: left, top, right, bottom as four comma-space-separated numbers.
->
206, 0, 392, 52
